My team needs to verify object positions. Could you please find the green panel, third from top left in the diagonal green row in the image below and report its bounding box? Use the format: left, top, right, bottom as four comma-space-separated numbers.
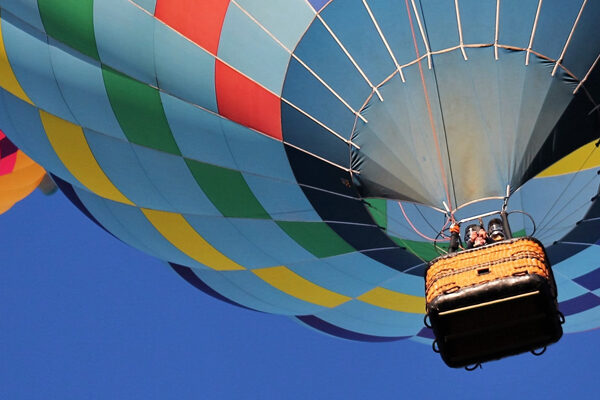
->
185, 158, 271, 219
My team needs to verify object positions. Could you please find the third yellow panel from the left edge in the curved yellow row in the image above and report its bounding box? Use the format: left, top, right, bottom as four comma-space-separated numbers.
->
141, 208, 246, 271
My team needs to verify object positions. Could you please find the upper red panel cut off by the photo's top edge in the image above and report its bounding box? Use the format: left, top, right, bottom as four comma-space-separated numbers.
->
154, 0, 229, 55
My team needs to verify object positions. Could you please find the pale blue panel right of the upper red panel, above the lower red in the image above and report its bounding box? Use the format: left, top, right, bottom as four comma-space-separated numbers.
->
218, 3, 290, 95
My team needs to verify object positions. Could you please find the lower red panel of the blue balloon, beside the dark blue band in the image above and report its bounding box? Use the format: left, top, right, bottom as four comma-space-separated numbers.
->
215, 60, 282, 140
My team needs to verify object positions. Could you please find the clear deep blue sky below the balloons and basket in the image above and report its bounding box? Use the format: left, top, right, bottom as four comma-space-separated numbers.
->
0, 191, 600, 400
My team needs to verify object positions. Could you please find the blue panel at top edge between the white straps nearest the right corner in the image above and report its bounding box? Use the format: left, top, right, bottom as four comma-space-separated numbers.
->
532, 0, 583, 60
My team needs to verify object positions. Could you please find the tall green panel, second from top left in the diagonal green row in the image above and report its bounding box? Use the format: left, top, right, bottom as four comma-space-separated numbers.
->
102, 66, 181, 155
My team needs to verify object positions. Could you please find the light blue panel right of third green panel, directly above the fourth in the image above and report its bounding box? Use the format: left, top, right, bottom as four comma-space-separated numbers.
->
243, 173, 321, 222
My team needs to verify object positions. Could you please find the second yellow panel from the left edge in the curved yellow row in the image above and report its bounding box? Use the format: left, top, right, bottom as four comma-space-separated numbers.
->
40, 110, 134, 205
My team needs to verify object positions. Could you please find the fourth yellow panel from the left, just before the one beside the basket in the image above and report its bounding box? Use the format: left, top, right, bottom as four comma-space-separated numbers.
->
252, 266, 352, 308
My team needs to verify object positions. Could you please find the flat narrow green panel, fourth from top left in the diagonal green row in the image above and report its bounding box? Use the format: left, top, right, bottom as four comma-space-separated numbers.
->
276, 221, 356, 258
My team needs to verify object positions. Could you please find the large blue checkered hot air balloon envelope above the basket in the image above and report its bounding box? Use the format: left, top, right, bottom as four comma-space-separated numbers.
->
0, 0, 600, 342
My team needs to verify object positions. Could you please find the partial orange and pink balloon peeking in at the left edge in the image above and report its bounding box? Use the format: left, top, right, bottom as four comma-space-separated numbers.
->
0, 131, 46, 214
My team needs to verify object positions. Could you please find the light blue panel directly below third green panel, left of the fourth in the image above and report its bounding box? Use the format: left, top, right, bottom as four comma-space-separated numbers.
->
229, 218, 317, 265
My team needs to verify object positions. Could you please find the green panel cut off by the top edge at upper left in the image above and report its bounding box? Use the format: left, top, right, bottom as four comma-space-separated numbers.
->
38, 0, 100, 60
